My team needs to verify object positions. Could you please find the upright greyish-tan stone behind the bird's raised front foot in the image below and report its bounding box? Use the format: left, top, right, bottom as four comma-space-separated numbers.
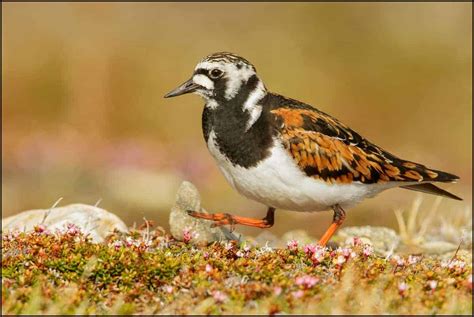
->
169, 181, 241, 245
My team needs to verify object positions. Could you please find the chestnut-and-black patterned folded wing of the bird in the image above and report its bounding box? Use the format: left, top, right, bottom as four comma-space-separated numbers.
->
270, 100, 458, 184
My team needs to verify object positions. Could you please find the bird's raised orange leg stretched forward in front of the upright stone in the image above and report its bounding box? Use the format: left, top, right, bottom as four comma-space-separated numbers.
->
188, 207, 275, 229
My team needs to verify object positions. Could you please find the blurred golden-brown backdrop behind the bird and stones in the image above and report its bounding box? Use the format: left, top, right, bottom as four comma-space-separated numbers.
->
2, 3, 472, 235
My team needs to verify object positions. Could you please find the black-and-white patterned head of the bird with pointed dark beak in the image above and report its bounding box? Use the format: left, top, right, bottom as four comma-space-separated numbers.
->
165, 52, 265, 102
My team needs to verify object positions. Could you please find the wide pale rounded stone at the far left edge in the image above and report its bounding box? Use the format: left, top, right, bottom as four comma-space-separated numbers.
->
2, 204, 128, 243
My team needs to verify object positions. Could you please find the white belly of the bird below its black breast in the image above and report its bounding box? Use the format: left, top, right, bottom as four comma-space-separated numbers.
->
208, 131, 394, 211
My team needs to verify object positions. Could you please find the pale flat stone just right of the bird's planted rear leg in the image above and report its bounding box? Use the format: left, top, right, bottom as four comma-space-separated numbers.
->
333, 226, 400, 256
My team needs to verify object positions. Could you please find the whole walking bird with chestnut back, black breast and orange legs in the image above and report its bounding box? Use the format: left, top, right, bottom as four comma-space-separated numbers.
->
164, 52, 462, 246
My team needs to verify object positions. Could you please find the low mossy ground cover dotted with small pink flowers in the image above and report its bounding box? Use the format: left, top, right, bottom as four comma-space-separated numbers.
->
2, 225, 472, 314
